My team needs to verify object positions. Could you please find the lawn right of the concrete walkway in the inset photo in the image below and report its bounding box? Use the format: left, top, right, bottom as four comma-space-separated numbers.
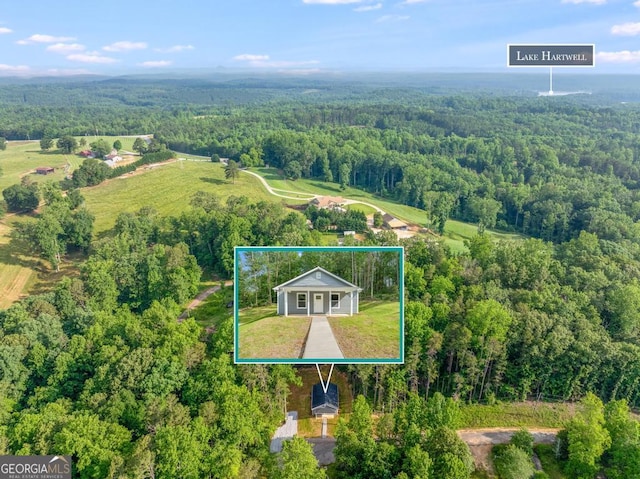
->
329, 301, 401, 359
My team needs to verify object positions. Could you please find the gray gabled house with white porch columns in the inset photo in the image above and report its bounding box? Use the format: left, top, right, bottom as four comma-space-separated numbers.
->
273, 266, 362, 316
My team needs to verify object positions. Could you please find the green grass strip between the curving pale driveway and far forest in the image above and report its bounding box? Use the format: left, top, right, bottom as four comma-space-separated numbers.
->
247, 168, 522, 252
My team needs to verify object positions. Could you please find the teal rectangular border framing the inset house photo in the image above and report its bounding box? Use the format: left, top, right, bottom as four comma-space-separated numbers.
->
233, 246, 404, 364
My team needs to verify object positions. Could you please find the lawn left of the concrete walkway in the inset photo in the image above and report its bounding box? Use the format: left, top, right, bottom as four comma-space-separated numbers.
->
237, 306, 311, 359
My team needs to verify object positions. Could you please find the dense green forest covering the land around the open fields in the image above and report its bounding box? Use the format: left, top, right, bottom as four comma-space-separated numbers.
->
0, 77, 640, 478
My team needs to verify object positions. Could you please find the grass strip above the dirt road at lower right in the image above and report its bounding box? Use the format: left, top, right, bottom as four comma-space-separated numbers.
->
460, 402, 574, 429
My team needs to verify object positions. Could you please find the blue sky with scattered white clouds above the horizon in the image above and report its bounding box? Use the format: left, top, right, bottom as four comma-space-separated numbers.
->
0, 0, 640, 76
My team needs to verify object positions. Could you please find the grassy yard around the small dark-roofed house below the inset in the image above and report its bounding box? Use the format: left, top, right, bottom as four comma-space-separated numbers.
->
287, 365, 353, 437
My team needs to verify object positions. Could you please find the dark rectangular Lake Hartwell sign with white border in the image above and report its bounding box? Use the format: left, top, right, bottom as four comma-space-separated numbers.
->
507, 45, 595, 67
